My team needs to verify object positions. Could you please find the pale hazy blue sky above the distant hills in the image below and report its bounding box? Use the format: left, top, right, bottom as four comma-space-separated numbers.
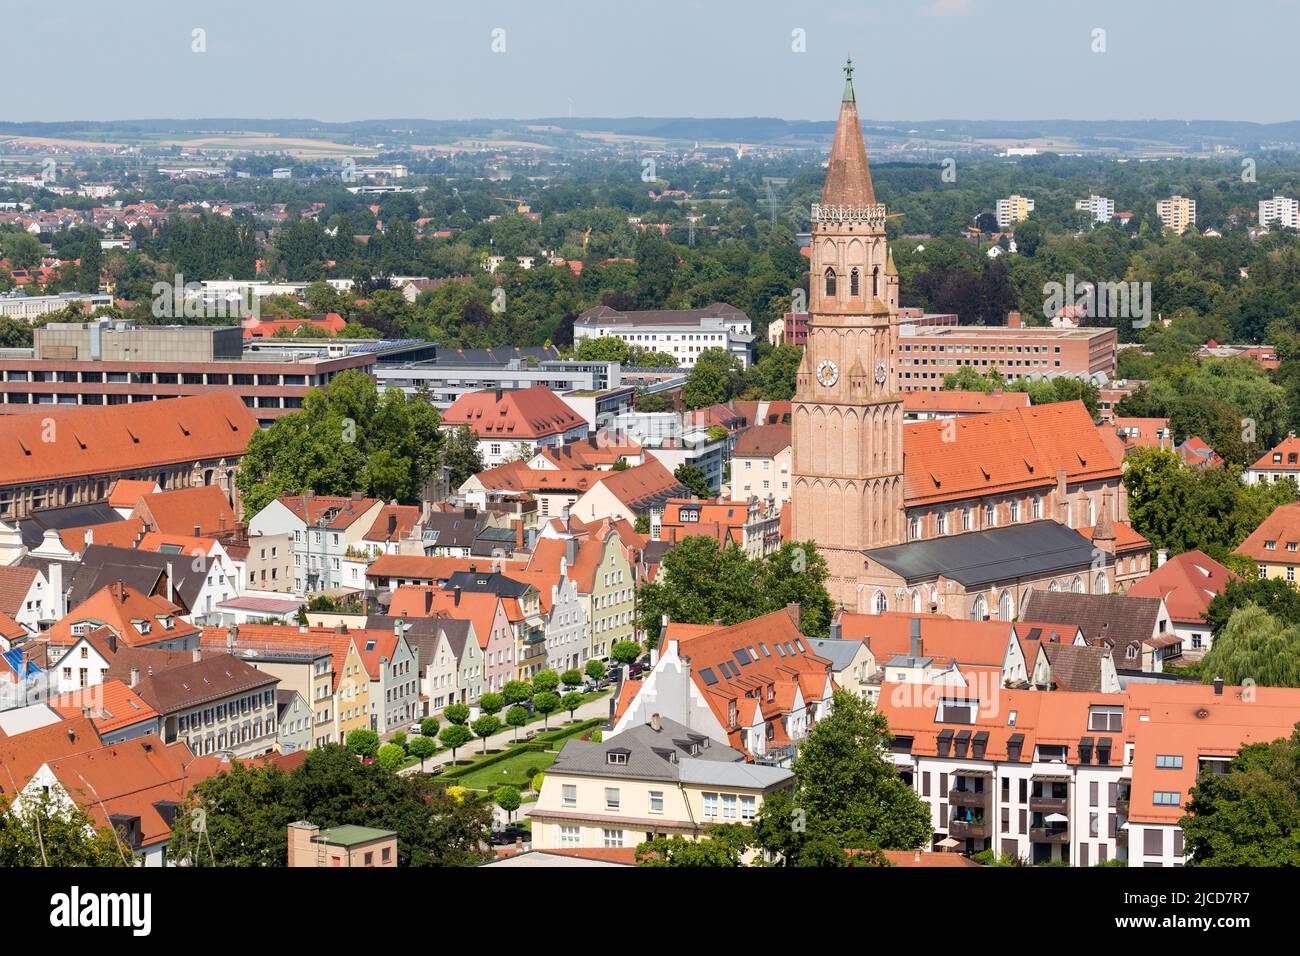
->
12, 0, 1300, 122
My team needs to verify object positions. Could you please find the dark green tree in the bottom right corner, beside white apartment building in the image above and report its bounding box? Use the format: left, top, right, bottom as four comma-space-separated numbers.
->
1179, 727, 1300, 866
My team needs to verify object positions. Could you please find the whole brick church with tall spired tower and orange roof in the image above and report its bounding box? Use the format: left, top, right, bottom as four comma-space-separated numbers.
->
788, 61, 1151, 620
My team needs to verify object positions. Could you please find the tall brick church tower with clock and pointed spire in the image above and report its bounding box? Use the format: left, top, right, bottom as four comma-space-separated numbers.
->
792, 60, 905, 611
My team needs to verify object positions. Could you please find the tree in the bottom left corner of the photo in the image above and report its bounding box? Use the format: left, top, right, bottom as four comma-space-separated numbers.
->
0, 795, 135, 868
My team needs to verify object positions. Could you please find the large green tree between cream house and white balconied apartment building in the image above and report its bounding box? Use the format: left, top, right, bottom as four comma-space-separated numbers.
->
754, 691, 933, 866
